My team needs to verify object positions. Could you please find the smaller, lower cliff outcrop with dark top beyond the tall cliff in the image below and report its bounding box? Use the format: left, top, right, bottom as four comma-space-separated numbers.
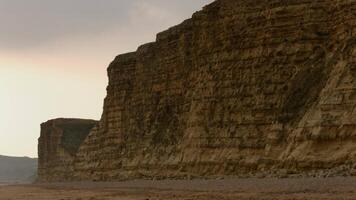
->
38, 119, 97, 181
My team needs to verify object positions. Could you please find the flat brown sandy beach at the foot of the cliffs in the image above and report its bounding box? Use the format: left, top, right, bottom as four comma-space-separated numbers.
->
0, 177, 356, 200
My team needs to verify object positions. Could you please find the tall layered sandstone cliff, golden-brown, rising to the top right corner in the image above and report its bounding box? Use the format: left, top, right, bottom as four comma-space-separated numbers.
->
41, 0, 356, 180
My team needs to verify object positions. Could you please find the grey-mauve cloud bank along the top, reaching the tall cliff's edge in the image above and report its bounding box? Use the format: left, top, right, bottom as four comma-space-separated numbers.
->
0, 0, 211, 50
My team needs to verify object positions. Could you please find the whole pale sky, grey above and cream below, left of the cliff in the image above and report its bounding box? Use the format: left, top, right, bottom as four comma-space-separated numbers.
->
0, 0, 213, 157
